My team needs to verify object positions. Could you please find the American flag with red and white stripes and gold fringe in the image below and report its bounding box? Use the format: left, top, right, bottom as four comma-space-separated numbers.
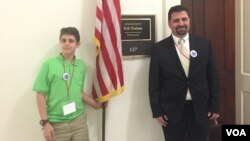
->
92, 0, 124, 102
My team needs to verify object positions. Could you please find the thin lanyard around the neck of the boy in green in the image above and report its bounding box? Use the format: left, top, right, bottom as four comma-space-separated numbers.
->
63, 59, 75, 96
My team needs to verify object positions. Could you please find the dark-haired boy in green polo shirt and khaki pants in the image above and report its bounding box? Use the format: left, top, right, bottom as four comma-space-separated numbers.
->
33, 27, 101, 141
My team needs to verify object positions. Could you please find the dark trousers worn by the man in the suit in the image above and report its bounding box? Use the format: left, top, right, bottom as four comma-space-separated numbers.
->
162, 102, 209, 141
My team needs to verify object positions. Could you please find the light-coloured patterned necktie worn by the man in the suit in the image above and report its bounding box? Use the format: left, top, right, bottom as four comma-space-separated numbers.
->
178, 38, 189, 76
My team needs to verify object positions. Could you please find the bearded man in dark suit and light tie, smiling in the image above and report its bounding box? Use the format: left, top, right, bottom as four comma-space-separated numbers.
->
149, 5, 220, 141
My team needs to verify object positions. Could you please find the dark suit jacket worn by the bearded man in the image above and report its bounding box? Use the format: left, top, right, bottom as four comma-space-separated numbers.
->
149, 35, 220, 123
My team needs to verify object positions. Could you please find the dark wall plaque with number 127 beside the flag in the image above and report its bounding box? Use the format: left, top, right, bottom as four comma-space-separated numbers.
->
121, 15, 155, 56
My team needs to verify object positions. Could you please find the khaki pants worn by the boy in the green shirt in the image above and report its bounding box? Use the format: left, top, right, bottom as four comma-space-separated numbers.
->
51, 114, 89, 141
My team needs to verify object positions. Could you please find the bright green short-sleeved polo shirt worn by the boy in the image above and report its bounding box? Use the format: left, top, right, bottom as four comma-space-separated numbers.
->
33, 55, 86, 122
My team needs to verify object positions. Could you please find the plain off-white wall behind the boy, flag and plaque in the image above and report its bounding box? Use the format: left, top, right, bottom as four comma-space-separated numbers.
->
0, 0, 180, 141
